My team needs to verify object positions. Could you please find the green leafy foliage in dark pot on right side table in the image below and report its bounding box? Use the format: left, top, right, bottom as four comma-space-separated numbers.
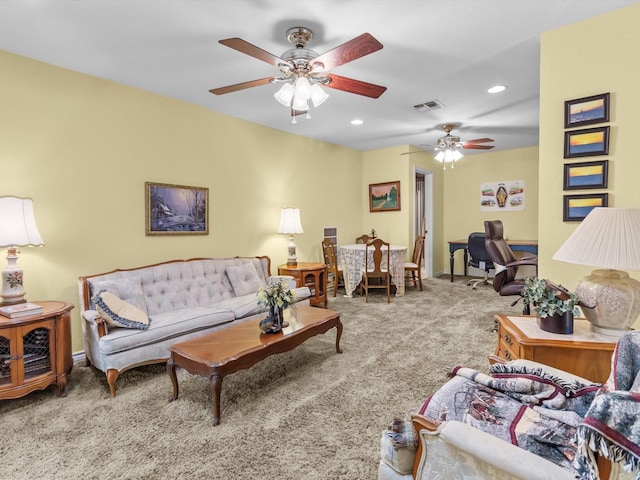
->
522, 277, 580, 318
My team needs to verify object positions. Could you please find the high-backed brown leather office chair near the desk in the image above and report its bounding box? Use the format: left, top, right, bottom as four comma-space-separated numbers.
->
484, 220, 538, 296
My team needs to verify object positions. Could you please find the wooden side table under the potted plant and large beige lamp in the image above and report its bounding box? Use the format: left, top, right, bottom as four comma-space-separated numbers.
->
495, 314, 617, 383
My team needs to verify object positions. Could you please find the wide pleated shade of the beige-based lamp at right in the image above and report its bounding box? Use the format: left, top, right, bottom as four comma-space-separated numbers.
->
553, 207, 640, 270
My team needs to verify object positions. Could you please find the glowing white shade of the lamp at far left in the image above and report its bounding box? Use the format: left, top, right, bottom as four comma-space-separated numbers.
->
0, 197, 44, 247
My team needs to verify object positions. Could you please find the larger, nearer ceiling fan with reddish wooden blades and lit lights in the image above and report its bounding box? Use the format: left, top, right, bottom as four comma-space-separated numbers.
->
209, 27, 387, 123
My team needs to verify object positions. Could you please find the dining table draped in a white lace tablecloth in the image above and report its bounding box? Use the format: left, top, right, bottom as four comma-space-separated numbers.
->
338, 243, 407, 297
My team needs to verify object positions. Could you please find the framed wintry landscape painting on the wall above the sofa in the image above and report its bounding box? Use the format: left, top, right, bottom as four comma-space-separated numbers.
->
145, 182, 209, 235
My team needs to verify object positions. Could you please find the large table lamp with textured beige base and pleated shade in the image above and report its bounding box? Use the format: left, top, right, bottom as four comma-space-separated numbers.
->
553, 207, 640, 337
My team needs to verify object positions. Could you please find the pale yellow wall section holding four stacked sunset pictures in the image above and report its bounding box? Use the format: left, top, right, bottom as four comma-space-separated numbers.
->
539, 4, 640, 318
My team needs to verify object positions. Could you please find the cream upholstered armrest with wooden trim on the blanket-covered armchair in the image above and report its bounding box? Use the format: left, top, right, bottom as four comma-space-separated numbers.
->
412, 415, 574, 480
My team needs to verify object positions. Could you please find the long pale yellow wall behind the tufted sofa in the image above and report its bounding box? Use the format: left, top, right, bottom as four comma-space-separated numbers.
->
0, 52, 363, 351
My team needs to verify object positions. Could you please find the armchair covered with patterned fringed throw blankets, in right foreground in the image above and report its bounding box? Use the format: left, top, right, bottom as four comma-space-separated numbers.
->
378, 331, 640, 480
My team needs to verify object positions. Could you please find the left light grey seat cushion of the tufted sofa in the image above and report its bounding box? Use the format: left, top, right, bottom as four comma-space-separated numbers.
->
99, 307, 234, 355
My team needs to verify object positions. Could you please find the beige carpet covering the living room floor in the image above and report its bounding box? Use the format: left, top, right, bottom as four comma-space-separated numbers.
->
0, 277, 519, 480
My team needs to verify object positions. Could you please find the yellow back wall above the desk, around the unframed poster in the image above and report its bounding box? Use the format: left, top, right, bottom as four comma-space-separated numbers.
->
442, 147, 538, 274
